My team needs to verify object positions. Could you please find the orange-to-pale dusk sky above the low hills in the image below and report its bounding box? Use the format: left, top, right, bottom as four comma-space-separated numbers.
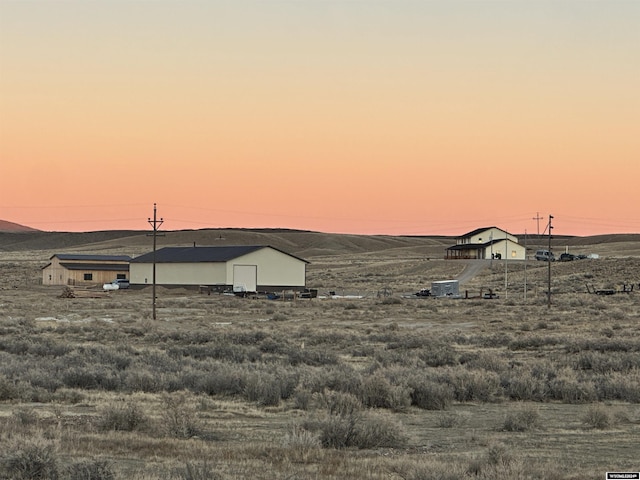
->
0, 0, 640, 235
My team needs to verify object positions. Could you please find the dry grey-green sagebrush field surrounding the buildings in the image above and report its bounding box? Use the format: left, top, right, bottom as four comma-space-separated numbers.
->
0, 231, 640, 480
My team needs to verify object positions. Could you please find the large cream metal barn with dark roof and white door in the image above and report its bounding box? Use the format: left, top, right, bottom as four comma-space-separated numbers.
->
129, 245, 309, 292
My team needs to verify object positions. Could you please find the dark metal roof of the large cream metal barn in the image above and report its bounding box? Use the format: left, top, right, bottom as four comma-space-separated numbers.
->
131, 245, 309, 263
